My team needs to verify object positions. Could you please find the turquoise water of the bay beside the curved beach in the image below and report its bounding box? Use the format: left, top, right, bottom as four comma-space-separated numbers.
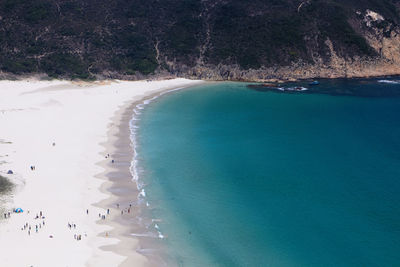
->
137, 80, 400, 266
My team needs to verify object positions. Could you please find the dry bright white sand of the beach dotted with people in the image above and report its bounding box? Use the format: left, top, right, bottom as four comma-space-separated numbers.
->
0, 79, 203, 267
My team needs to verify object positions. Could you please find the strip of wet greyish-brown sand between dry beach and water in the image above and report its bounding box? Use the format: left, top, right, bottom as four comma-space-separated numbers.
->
94, 84, 206, 267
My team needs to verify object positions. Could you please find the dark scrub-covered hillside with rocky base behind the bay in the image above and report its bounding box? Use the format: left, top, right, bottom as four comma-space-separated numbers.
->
0, 0, 400, 80
